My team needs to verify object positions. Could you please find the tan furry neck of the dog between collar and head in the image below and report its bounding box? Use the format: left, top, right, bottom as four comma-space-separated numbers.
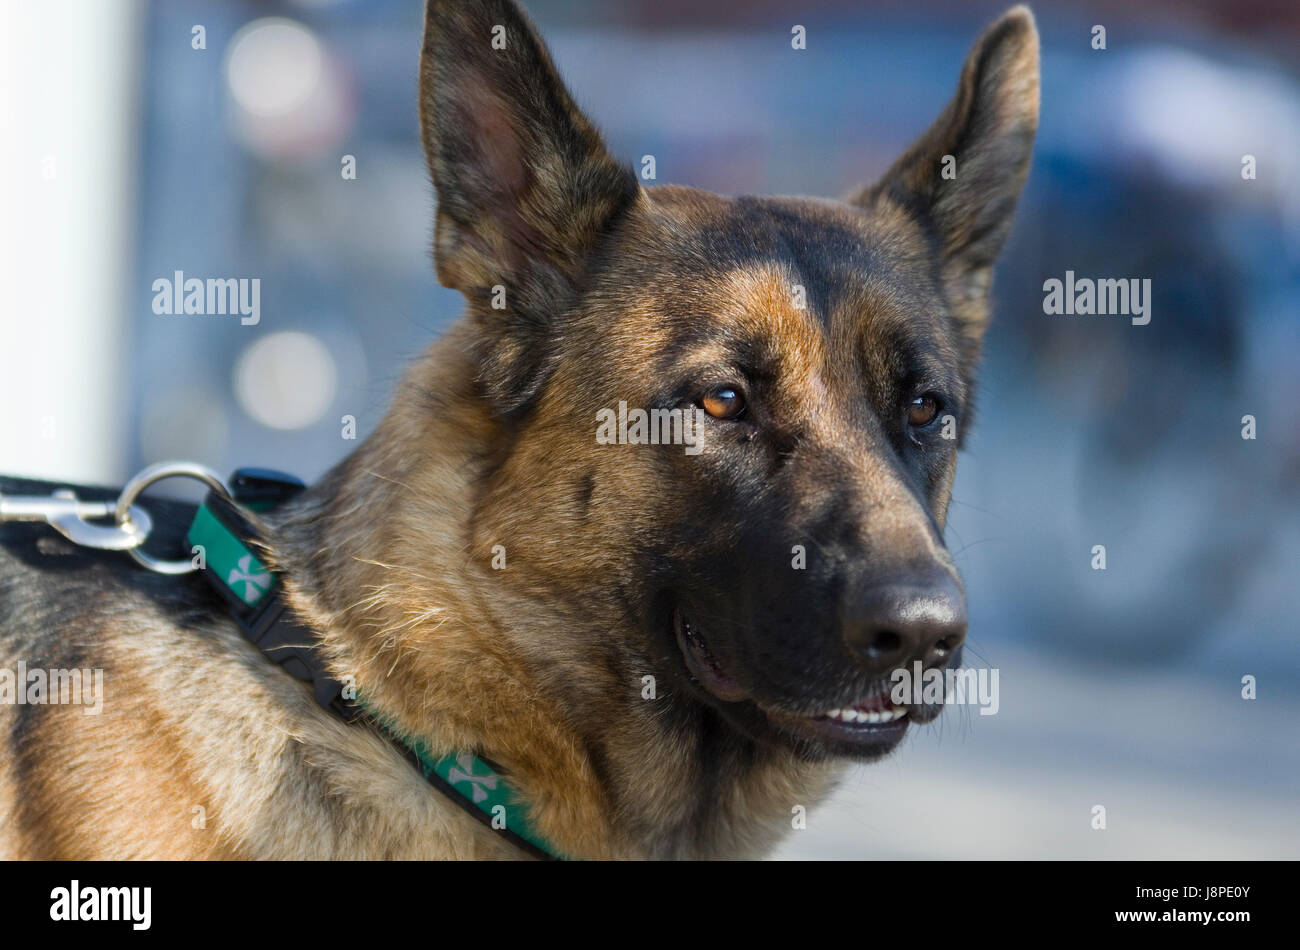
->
273, 329, 835, 859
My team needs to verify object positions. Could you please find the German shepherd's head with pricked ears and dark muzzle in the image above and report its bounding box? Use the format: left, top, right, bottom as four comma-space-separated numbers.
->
420, 0, 1039, 758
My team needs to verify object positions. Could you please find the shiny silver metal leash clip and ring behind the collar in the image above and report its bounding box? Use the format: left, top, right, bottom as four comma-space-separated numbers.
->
0, 461, 230, 574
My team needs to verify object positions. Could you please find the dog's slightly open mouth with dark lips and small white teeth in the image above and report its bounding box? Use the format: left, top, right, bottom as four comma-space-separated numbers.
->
672, 607, 911, 754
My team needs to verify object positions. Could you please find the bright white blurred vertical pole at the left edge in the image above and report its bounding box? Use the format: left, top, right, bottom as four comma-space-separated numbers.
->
0, 0, 142, 482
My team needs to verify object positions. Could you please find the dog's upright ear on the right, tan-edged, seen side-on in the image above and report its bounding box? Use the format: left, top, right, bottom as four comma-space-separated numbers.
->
850, 6, 1039, 359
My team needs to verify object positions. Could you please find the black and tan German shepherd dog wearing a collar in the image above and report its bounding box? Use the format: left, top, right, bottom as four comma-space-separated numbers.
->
0, 0, 1039, 859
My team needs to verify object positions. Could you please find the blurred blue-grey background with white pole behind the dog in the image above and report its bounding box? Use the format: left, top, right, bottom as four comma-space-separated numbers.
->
0, 0, 1300, 858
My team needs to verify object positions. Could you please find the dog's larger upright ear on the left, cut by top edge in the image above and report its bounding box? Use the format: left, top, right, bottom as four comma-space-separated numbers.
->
420, 0, 640, 412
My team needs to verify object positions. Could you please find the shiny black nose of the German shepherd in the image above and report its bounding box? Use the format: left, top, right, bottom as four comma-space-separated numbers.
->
845, 572, 966, 674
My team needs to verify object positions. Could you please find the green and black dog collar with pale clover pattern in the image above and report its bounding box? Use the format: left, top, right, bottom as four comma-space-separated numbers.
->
189, 469, 559, 858
